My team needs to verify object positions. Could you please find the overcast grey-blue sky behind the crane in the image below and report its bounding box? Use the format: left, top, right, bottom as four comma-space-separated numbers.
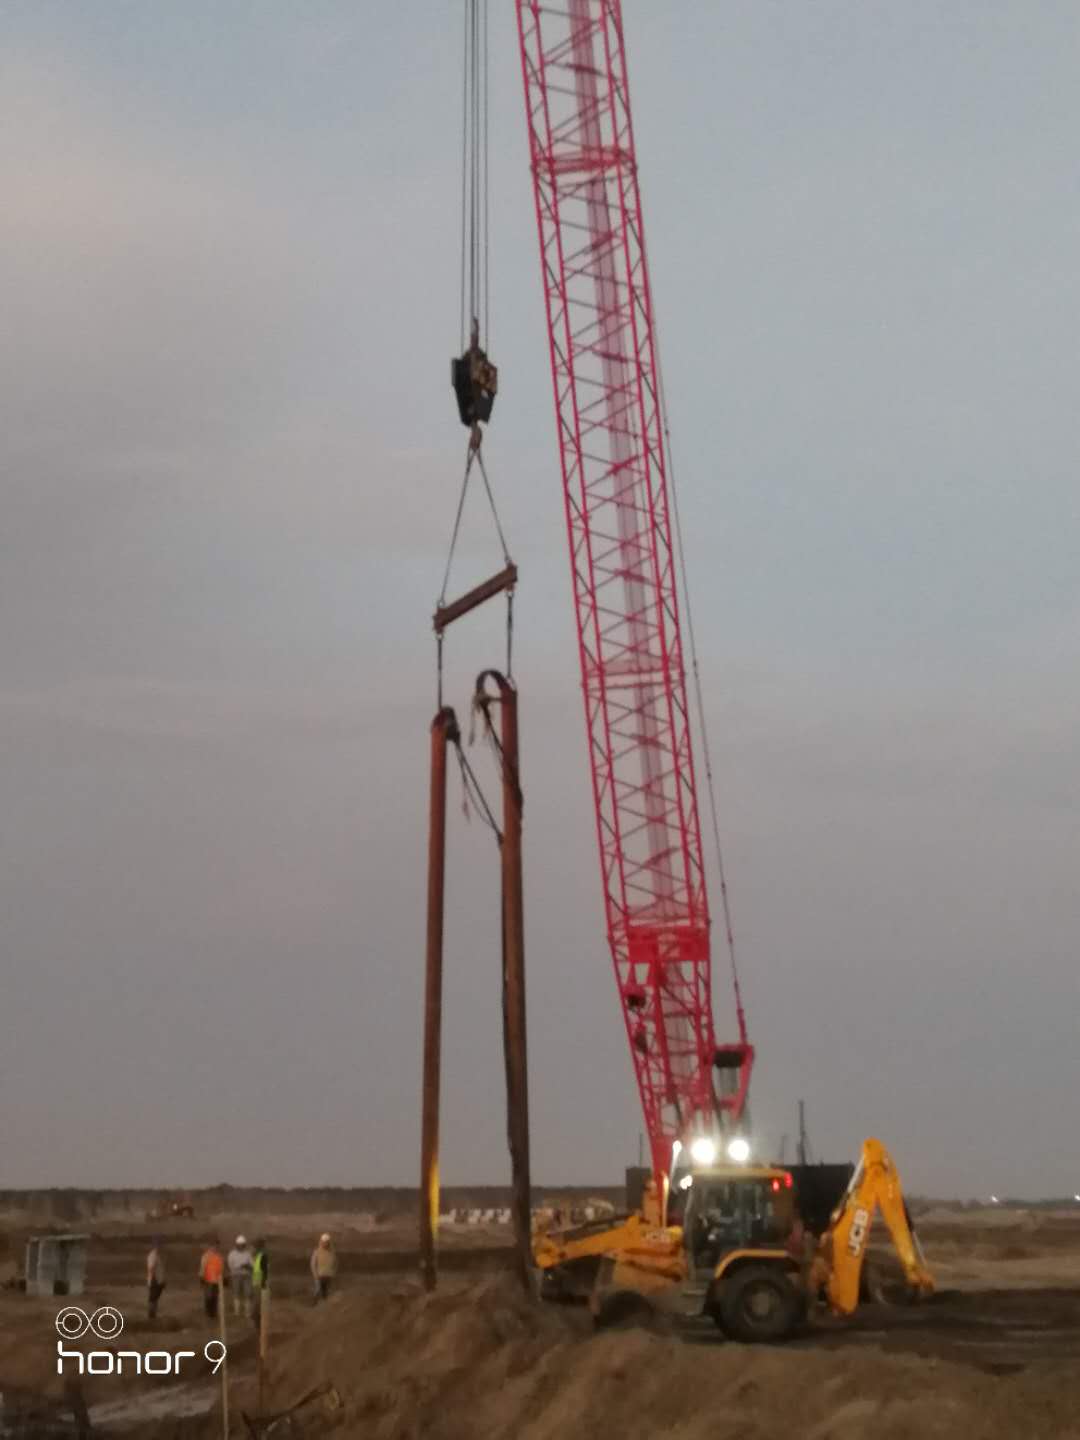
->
0, 0, 1080, 1195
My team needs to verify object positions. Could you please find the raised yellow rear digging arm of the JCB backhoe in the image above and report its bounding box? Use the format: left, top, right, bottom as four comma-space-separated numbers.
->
811, 1139, 933, 1315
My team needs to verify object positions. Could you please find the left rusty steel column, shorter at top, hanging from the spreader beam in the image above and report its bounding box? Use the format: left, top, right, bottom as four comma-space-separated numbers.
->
420, 706, 458, 1290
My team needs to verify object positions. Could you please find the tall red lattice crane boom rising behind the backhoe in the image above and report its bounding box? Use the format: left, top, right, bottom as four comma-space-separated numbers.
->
517, 0, 753, 1175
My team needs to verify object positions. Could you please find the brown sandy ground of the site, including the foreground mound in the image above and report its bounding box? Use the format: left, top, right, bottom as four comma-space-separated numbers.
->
0, 1211, 1080, 1440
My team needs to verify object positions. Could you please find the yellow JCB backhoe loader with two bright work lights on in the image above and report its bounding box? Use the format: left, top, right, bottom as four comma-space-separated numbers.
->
534, 1139, 933, 1341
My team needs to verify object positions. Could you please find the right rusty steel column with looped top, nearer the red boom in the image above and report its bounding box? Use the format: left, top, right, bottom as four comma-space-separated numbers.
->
477, 670, 533, 1289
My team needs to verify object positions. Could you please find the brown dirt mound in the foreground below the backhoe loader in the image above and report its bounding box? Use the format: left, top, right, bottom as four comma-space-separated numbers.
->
216, 1277, 1080, 1440
